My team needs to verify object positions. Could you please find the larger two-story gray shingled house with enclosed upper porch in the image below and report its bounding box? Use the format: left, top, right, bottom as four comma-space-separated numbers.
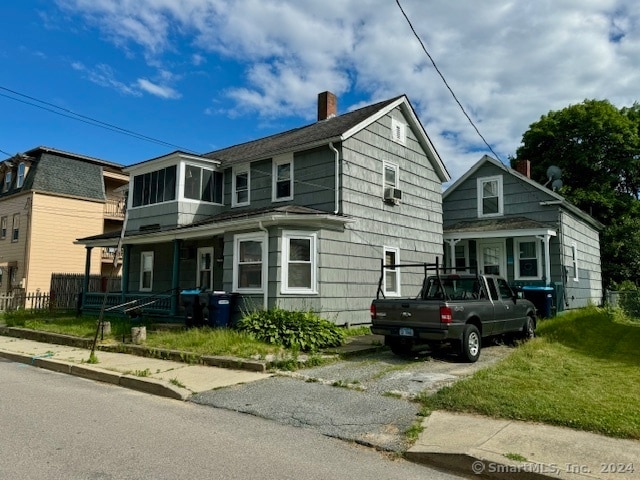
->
78, 92, 450, 325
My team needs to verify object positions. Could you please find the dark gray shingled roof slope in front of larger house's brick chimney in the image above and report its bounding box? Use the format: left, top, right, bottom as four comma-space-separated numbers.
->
204, 96, 402, 165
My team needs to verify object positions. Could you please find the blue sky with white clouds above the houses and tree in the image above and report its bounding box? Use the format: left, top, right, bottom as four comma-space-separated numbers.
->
0, 0, 640, 184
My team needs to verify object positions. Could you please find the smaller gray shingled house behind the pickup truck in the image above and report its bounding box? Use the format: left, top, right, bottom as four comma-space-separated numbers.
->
443, 155, 603, 315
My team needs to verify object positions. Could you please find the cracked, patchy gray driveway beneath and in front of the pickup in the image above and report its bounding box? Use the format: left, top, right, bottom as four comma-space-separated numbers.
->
192, 345, 513, 452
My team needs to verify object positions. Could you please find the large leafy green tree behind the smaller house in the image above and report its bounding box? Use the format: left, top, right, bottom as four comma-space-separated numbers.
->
511, 100, 640, 288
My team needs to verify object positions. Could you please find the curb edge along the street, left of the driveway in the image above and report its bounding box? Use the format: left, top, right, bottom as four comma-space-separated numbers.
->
0, 350, 191, 401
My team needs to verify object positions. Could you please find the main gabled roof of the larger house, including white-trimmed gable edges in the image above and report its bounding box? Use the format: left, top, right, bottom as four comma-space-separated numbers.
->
204, 95, 451, 182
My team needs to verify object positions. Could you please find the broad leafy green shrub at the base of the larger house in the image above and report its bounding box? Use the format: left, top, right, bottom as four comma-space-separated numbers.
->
237, 308, 345, 352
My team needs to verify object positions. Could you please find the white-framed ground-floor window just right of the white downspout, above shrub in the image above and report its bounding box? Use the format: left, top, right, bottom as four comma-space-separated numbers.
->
282, 231, 317, 293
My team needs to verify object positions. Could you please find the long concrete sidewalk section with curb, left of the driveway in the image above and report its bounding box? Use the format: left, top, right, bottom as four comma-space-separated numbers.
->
0, 336, 270, 400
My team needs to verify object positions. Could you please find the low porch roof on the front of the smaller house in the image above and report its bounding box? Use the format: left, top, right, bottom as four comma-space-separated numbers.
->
443, 217, 557, 240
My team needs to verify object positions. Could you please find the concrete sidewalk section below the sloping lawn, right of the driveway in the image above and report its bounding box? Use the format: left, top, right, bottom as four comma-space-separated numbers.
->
406, 411, 640, 480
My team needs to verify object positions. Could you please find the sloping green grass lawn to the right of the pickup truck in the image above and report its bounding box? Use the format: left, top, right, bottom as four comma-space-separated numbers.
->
420, 307, 640, 439
